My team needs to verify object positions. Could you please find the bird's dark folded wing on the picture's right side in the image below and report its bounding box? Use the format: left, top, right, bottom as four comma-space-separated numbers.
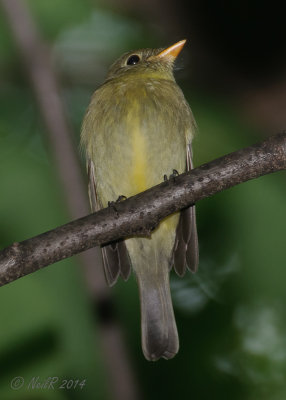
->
173, 144, 199, 276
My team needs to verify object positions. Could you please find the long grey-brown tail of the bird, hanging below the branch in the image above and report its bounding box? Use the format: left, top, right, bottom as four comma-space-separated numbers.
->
136, 268, 179, 361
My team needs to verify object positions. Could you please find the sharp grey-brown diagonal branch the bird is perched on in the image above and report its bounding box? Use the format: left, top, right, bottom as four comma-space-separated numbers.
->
0, 132, 286, 285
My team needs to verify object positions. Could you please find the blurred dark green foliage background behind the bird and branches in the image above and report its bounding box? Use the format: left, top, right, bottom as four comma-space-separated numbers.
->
0, 0, 286, 400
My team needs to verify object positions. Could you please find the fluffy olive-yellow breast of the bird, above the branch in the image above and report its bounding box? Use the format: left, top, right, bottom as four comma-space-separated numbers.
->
88, 80, 189, 205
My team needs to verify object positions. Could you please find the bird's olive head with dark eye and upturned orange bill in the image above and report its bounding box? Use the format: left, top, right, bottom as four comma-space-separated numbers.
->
106, 40, 186, 81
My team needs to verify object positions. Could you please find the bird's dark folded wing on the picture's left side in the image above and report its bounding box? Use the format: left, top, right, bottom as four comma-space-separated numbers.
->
87, 159, 131, 286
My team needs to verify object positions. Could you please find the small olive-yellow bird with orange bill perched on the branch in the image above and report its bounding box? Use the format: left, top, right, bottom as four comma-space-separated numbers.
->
81, 40, 199, 361
